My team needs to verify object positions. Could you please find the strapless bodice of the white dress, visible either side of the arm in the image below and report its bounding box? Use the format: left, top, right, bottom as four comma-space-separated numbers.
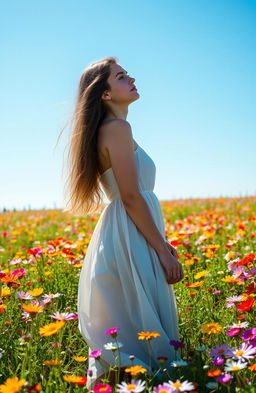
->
100, 145, 156, 201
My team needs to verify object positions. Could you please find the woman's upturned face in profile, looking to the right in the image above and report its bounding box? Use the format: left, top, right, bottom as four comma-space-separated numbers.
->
102, 63, 140, 104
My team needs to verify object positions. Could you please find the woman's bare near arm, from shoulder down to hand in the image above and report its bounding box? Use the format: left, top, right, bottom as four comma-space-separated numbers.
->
101, 119, 183, 284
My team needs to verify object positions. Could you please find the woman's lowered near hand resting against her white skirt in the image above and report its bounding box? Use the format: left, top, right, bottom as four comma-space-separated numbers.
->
158, 241, 184, 284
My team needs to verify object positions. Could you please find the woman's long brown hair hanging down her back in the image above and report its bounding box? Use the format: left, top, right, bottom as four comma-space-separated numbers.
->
59, 56, 118, 215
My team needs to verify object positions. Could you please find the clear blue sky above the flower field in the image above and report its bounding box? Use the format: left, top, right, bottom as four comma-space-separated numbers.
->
0, 0, 256, 209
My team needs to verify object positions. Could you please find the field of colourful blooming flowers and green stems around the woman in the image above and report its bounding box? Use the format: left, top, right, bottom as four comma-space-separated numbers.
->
0, 197, 256, 393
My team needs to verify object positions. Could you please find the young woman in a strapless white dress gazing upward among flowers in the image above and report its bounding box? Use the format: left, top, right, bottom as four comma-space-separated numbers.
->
64, 57, 183, 389
